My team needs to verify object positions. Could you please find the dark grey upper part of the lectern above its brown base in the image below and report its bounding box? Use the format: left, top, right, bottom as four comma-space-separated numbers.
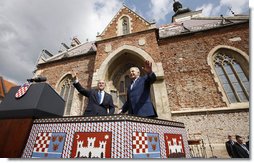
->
0, 83, 65, 118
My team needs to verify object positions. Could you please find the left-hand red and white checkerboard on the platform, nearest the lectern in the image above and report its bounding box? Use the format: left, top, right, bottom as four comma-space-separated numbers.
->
34, 133, 52, 152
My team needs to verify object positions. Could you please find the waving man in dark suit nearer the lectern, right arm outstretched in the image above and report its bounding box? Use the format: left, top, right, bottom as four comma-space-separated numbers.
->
73, 75, 115, 115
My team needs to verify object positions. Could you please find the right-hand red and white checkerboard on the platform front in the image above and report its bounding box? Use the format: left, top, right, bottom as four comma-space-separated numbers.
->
132, 132, 148, 154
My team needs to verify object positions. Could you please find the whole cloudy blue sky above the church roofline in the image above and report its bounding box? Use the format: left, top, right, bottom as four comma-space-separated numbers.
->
0, 0, 249, 84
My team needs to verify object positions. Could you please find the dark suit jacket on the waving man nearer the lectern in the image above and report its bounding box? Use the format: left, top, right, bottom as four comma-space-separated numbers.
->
73, 83, 115, 115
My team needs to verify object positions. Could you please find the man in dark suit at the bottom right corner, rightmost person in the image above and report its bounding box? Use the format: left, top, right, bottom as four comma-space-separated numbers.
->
233, 135, 249, 158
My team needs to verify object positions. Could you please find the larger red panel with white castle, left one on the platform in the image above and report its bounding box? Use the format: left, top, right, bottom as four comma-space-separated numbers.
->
71, 132, 112, 158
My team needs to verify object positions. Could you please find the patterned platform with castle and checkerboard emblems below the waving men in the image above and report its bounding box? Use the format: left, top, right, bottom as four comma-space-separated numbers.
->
22, 115, 190, 158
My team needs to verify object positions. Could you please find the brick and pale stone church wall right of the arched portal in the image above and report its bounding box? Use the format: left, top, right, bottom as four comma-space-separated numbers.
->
159, 24, 250, 158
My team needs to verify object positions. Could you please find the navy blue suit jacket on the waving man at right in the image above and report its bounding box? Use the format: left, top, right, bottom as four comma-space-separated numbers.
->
122, 72, 157, 117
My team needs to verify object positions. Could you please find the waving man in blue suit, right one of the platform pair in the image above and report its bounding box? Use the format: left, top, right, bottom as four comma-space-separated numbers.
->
120, 61, 157, 118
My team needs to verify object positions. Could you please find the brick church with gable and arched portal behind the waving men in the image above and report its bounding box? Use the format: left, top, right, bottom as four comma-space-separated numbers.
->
35, 3, 250, 157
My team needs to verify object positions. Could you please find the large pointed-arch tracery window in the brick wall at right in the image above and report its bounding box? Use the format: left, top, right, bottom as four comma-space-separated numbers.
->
214, 52, 250, 103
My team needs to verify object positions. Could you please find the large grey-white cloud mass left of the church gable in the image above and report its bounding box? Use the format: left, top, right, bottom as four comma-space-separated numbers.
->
0, 0, 122, 84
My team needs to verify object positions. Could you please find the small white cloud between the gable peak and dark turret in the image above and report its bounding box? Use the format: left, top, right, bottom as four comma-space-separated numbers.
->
148, 0, 173, 21
